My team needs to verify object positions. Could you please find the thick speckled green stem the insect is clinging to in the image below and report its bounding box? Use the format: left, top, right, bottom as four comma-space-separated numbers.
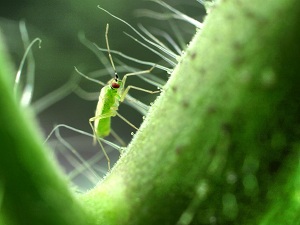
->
82, 0, 300, 225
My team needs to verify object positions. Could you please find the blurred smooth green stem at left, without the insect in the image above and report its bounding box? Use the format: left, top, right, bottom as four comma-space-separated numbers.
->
0, 33, 86, 225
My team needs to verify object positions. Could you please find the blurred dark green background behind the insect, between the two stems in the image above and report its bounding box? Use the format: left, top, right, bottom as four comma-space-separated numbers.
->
0, 0, 205, 190
